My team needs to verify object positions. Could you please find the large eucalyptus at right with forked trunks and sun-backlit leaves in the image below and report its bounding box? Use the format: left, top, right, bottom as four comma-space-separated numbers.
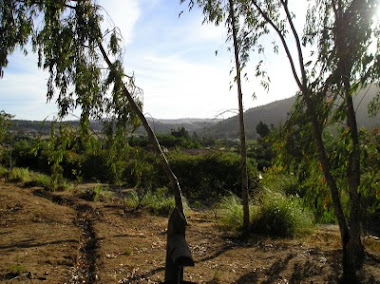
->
223, 0, 380, 283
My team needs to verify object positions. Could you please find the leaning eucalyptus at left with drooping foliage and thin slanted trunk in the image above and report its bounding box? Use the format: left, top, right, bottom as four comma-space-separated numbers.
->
0, 0, 183, 212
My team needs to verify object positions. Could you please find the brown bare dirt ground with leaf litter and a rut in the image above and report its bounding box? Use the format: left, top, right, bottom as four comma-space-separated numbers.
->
0, 183, 380, 283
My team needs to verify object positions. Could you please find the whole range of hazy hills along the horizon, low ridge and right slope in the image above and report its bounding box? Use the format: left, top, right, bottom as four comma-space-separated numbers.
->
10, 86, 380, 139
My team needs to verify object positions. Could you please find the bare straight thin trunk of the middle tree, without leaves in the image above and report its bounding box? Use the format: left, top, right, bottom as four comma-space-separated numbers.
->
229, 0, 249, 231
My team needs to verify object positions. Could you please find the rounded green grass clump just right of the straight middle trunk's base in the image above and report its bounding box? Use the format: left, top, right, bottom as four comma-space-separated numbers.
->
252, 188, 313, 238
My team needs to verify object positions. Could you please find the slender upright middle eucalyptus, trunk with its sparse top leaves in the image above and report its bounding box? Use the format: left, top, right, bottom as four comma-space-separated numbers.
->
180, 0, 250, 232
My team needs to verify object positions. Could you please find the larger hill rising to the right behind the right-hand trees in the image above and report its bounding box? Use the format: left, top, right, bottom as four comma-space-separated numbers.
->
207, 86, 380, 138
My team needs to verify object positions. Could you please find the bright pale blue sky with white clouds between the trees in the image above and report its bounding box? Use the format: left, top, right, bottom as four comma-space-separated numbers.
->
0, 0, 306, 120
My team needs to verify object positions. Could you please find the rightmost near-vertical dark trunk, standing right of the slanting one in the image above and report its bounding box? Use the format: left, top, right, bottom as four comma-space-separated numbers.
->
333, 1, 364, 276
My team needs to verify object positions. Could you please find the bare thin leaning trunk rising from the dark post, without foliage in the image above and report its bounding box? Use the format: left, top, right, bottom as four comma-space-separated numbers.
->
98, 42, 184, 214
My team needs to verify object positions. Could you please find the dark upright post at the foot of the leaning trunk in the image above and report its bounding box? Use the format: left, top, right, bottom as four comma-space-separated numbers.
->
165, 207, 194, 283
